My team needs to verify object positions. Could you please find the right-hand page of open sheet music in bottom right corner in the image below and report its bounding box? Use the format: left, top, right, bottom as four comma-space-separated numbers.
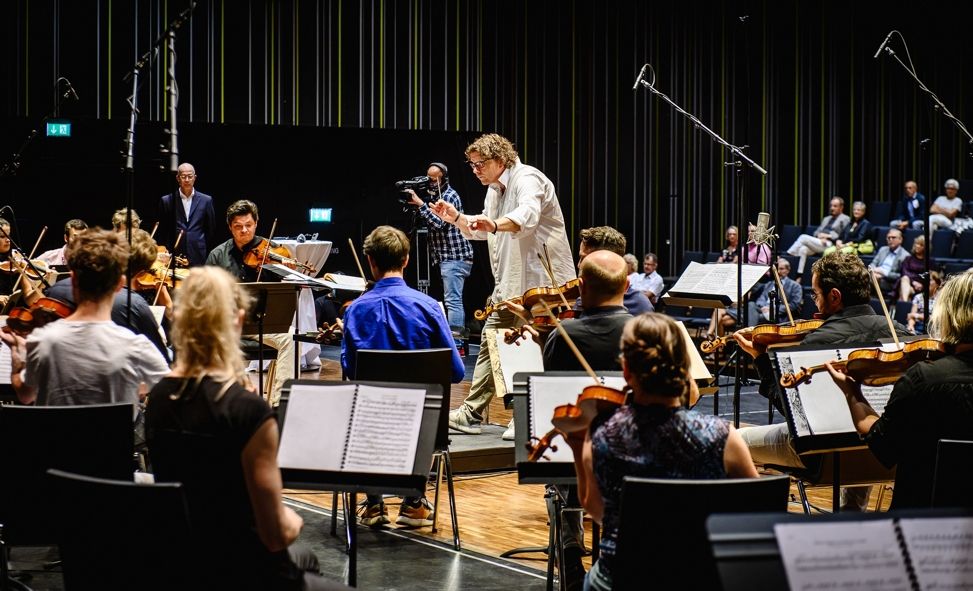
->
899, 517, 973, 589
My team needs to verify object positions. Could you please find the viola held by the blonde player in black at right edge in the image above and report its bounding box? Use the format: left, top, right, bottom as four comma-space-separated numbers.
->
780, 338, 948, 388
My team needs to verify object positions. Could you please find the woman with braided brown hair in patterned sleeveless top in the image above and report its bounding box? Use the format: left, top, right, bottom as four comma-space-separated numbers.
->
568, 313, 757, 591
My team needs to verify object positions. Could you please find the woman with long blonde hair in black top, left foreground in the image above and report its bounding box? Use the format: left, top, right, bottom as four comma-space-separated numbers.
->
146, 267, 338, 589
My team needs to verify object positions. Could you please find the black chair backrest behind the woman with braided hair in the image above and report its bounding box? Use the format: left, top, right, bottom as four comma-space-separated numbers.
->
612, 476, 790, 589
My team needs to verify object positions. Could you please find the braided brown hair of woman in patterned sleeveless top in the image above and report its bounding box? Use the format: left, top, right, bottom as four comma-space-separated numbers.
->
621, 312, 692, 398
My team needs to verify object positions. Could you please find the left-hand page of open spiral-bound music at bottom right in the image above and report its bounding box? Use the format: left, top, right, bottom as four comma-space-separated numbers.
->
774, 519, 912, 591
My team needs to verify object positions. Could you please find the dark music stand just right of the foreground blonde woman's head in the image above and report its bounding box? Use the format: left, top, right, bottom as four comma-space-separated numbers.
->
240, 282, 300, 398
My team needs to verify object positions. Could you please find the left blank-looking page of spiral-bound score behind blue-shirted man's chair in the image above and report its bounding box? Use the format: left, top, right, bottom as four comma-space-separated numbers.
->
277, 384, 355, 471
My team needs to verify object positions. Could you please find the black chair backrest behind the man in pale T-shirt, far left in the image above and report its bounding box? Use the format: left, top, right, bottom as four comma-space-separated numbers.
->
0, 404, 134, 545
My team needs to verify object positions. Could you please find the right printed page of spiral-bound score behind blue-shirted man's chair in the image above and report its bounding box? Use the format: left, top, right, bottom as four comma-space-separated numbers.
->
342, 386, 426, 474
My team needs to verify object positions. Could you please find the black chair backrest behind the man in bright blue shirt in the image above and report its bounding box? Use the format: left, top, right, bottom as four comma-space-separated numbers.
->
349, 348, 453, 450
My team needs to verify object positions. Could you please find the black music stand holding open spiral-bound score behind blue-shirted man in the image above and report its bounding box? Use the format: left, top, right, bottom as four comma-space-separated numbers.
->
277, 380, 443, 587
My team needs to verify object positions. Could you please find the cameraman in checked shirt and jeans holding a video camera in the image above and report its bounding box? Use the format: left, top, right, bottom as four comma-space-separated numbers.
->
406, 162, 473, 344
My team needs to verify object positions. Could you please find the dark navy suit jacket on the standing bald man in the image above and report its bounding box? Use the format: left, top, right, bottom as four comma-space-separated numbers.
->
156, 189, 216, 267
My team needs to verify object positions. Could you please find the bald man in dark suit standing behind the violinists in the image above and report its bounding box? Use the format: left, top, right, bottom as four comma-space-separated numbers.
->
156, 162, 216, 267
